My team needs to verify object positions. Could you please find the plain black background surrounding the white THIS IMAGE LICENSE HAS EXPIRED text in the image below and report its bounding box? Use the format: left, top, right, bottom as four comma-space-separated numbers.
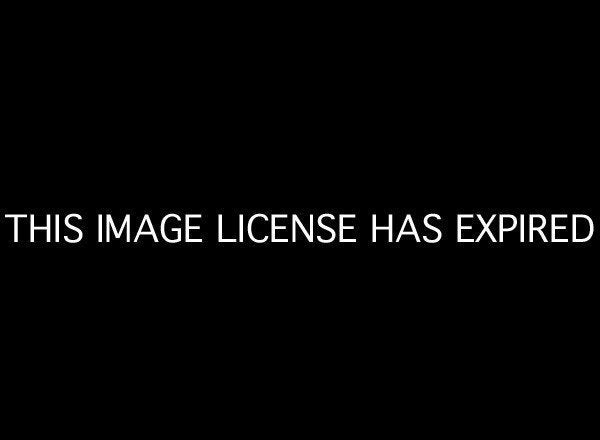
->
1, 5, 598, 433
